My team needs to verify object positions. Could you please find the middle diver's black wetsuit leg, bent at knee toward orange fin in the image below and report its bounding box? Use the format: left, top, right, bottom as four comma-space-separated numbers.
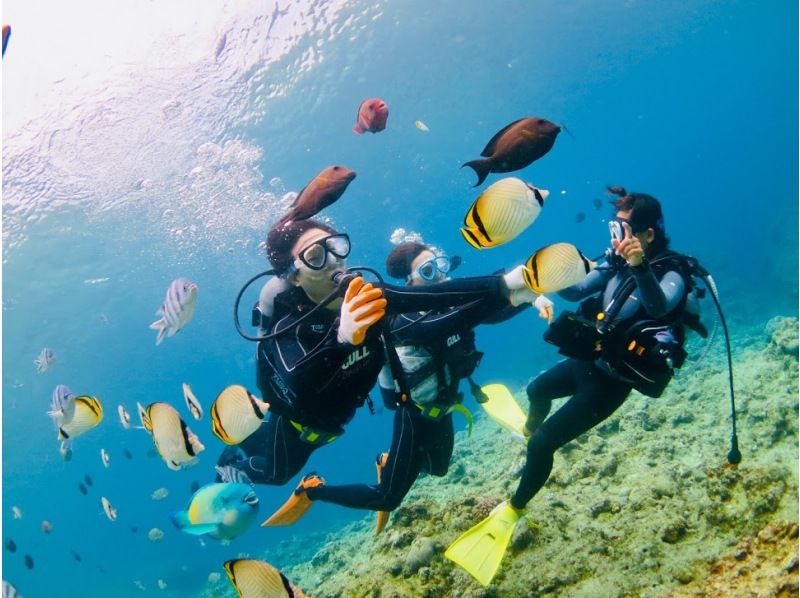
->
308, 407, 423, 511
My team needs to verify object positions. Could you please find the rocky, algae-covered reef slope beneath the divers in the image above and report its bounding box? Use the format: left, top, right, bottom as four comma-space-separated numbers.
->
203, 318, 798, 598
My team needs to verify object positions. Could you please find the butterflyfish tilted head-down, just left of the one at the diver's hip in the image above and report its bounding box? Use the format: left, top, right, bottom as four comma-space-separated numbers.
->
137, 403, 205, 470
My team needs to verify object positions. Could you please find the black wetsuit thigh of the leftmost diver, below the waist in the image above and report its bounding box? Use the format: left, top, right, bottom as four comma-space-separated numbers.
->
220, 413, 316, 486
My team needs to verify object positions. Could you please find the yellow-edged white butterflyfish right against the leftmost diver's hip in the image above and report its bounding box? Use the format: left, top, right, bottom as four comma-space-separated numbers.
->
211, 384, 269, 444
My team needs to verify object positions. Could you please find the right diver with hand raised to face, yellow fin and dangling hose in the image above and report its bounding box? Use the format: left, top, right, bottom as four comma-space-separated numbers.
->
445, 187, 741, 585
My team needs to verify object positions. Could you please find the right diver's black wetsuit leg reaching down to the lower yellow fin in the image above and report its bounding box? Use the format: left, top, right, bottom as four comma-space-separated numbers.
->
511, 362, 631, 509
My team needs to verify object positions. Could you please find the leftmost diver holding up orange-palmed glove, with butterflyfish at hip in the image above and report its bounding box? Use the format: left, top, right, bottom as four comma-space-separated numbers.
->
211, 219, 535, 496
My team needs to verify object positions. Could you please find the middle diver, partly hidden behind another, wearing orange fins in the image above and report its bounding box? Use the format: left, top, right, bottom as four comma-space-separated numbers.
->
264, 242, 553, 534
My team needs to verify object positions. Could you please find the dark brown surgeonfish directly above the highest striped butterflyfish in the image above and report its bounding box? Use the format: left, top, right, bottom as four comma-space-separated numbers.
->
461, 117, 561, 187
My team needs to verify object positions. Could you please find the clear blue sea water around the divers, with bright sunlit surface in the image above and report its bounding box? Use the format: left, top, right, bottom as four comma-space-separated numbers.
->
2, 0, 798, 597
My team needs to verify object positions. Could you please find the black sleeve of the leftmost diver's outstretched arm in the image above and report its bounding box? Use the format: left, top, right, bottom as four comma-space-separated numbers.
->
382, 276, 508, 314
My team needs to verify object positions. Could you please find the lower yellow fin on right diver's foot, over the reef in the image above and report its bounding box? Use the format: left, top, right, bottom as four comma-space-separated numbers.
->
444, 502, 520, 587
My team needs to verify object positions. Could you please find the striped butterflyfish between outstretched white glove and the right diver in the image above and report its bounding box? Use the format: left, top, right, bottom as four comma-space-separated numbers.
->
522, 243, 597, 294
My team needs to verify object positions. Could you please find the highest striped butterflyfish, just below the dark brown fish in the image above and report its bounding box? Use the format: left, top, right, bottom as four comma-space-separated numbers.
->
461, 177, 550, 249
